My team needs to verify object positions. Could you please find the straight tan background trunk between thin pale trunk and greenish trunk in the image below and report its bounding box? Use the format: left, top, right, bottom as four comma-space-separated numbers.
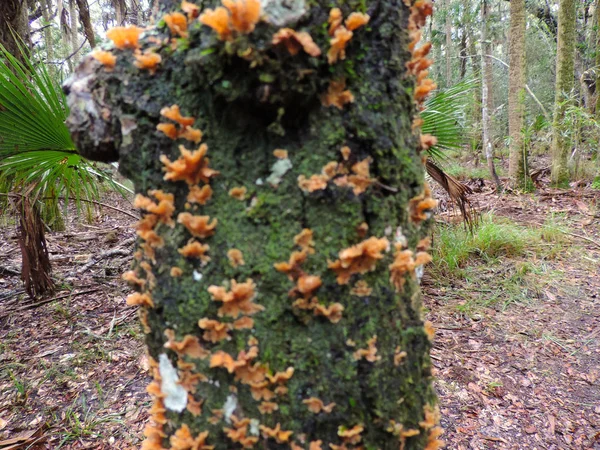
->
508, 0, 528, 187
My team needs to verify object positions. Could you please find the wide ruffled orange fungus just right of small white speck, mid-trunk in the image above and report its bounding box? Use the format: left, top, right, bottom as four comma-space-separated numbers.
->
208, 278, 265, 319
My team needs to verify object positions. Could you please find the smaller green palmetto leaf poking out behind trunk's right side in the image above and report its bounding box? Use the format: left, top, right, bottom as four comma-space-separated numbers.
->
421, 79, 478, 159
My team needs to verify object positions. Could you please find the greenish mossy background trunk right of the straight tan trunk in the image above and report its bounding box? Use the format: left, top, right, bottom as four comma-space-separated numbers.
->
552, 0, 577, 185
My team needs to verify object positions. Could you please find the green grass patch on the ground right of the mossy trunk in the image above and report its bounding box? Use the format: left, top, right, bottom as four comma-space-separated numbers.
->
430, 213, 570, 315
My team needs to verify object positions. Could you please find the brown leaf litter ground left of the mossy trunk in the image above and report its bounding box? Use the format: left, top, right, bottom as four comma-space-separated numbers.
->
0, 192, 150, 449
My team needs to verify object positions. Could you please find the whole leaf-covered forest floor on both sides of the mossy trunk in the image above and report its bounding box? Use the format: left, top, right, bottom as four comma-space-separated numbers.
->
0, 174, 600, 450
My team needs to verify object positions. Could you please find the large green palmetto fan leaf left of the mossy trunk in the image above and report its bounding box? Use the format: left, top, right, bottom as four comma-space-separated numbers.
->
0, 45, 127, 220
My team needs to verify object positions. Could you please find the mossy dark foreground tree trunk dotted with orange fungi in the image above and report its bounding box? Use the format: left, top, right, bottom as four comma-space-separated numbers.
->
68, 0, 438, 449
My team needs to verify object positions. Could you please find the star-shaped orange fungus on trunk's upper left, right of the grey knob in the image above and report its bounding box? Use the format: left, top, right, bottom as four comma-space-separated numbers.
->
160, 144, 219, 185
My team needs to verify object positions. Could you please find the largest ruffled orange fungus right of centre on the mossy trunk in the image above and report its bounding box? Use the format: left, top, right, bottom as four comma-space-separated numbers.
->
328, 236, 390, 284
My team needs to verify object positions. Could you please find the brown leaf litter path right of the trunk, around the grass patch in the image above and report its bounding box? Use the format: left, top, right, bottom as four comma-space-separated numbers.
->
424, 185, 600, 450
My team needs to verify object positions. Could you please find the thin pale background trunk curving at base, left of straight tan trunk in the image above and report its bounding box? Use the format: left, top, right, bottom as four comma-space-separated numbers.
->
481, 0, 502, 191
